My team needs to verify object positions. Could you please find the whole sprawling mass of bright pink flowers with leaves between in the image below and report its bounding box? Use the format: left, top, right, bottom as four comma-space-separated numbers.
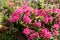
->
10, 2, 60, 40
